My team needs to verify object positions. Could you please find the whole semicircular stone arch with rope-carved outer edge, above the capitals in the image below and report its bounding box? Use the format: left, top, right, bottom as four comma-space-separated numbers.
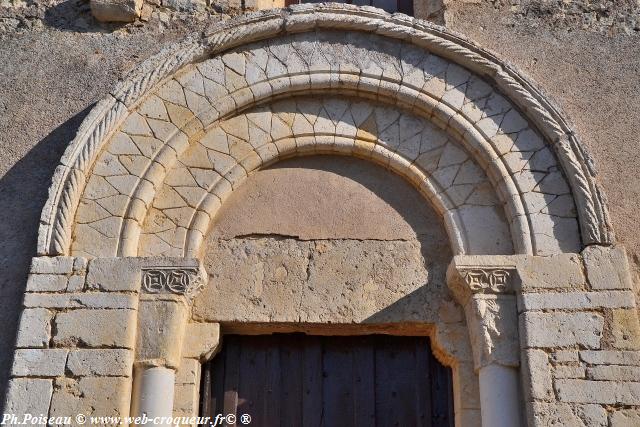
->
39, 6, 611, 257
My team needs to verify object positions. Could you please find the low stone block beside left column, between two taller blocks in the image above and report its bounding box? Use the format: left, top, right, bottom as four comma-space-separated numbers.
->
67, 348, 133, 377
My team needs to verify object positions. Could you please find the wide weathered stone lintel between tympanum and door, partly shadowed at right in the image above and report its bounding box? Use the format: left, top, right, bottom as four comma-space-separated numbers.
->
194, 238, 449, 323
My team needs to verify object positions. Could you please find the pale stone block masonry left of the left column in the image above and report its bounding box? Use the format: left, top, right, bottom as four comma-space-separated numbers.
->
5, 257, 139, 417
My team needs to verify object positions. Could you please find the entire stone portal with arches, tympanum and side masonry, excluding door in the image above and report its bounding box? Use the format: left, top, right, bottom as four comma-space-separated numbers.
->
4, 0, 640, 427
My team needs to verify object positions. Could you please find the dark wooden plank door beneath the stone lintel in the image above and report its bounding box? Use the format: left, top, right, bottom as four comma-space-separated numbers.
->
201, 334, 454, 427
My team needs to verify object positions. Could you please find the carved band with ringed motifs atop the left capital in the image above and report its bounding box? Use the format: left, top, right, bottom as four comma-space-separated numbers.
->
142, 267, 204, 299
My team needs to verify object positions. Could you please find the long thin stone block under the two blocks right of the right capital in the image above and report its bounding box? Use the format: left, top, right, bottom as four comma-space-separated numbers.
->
519, 291, 635, 310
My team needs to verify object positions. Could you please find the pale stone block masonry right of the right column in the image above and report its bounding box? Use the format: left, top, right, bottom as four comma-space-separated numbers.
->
455, 246, 640, 427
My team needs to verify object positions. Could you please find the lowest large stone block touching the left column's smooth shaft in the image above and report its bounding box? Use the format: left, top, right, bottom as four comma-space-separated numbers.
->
50, 377, 131, 417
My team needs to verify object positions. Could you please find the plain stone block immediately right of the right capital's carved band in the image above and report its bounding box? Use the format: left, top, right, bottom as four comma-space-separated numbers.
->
517, 254, 585, 290
